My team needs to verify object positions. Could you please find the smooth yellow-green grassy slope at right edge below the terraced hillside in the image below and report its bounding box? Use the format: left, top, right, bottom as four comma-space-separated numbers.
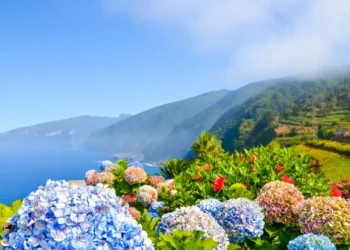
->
296, 144, 350, 181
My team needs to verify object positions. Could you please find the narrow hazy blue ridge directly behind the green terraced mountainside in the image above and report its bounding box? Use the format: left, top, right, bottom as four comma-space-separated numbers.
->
144, 80, 275, 159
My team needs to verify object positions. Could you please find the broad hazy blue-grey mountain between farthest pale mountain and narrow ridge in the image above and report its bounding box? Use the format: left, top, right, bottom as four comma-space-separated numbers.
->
84, 90, 230, 160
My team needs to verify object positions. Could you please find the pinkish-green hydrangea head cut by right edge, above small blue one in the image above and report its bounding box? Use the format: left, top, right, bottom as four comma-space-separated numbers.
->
299, 197, 350, 245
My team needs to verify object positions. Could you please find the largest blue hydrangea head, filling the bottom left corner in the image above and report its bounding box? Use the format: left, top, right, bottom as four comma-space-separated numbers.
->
1, 180, 154, 250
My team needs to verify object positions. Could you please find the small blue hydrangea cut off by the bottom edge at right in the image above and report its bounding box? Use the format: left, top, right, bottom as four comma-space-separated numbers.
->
288, 234, 336, 250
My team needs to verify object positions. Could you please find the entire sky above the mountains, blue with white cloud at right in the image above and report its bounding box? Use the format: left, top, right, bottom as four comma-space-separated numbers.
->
0, 0, 350, 132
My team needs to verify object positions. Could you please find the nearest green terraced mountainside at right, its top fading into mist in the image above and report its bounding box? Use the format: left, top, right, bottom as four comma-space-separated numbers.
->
210, 66, 350, 151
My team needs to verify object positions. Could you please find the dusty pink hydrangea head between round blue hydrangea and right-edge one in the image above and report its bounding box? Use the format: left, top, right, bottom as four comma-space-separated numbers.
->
256, 181, 304, 224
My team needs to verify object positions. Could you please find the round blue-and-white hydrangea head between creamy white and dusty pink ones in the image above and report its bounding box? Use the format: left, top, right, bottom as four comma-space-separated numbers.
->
219, 198, 264, 243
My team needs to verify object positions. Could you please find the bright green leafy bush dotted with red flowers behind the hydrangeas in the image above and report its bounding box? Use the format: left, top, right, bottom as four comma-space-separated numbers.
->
160, 133, 330, 209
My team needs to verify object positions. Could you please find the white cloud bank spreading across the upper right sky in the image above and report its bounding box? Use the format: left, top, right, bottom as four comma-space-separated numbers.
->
103, 0, 350, 84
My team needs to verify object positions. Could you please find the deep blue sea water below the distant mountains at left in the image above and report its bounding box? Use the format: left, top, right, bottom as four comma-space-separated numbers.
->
0, 150, 159, 204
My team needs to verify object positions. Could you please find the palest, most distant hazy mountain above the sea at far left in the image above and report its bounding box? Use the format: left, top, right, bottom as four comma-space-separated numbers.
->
0, 114, 131, 150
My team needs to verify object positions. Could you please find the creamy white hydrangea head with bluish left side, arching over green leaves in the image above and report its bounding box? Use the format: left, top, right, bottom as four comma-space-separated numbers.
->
157, 206, 229, 250
